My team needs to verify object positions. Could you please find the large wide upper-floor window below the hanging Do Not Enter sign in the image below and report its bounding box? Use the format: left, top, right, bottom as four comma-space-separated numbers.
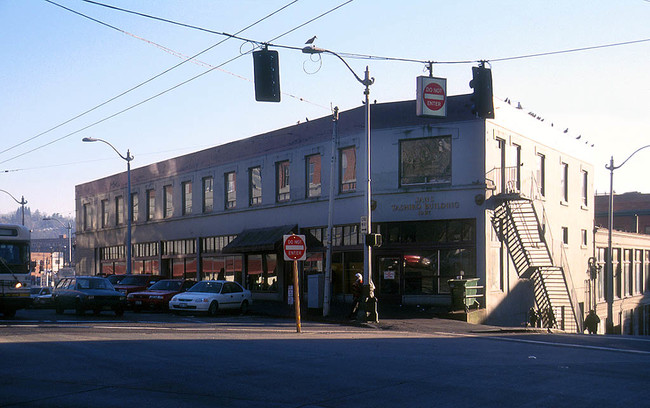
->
400, 136, 451, 185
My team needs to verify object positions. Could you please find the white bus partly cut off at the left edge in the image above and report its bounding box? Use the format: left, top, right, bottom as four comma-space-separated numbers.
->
0, 224, 31, 317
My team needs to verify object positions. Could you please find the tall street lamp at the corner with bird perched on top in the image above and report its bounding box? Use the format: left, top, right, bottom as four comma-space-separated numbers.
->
302, 45, 379, 321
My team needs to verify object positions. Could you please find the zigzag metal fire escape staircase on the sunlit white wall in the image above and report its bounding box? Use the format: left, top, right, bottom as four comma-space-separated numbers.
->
492, 196, 582, 332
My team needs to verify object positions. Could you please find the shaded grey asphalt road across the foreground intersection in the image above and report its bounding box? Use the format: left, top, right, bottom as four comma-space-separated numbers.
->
0, 310, 650, 408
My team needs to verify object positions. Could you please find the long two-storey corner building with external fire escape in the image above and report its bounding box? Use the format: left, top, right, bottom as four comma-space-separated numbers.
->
75, 95, 594, 330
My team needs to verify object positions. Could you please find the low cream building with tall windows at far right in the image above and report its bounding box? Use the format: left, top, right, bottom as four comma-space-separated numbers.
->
587, 228, 650, 335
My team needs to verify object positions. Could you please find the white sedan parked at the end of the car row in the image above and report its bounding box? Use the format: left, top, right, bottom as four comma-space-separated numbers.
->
169, 280, 253, 316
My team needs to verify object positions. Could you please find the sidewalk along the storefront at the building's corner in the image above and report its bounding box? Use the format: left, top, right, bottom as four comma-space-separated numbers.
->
250, 301, 547, 334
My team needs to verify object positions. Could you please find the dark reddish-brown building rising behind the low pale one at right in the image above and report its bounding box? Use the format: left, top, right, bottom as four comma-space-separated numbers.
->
595, 192, 650, 234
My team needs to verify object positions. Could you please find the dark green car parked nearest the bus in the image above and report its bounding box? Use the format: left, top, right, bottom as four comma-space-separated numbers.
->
52, 276, 126, 316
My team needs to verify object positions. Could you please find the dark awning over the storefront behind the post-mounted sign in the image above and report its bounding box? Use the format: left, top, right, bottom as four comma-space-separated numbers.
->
221, 225, 323, 254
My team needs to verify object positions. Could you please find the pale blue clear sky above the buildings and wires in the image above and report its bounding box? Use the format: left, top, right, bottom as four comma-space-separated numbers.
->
0, 0, 650, 217
